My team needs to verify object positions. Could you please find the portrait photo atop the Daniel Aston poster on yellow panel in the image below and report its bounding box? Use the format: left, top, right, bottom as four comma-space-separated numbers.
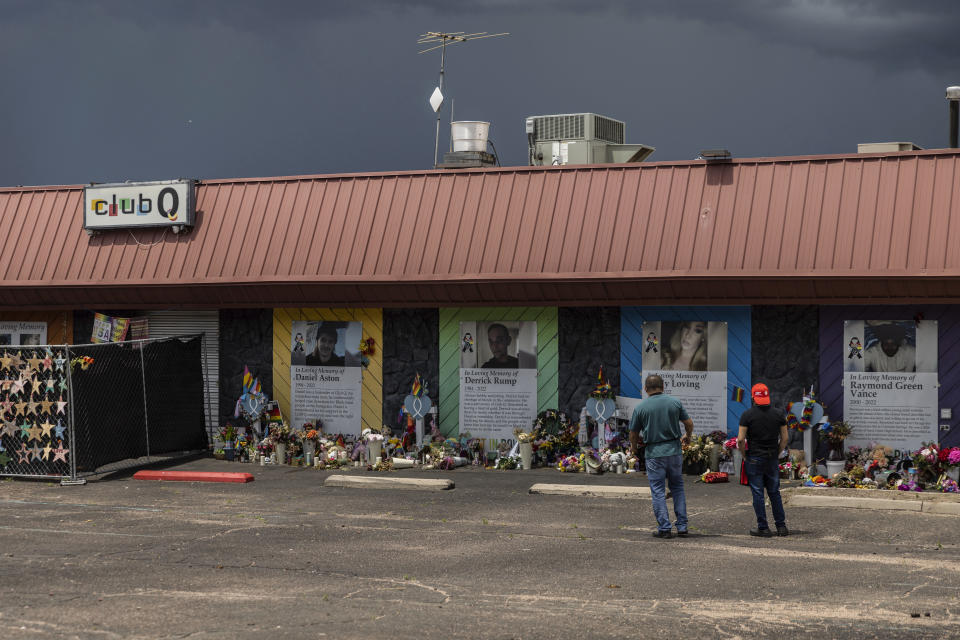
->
290, 320, 362, 367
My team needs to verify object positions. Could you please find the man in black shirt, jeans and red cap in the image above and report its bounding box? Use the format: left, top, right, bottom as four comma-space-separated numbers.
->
737, 382, 790, 538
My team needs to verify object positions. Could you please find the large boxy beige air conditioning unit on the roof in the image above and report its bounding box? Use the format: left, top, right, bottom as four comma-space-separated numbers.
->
526, 113, 654, 165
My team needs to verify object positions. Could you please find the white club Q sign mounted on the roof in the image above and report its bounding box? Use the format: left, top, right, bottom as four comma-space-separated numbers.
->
83, 180, 195, 231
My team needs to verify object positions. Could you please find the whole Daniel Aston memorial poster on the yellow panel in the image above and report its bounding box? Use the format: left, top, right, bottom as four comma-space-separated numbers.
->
290, 320, 363, 436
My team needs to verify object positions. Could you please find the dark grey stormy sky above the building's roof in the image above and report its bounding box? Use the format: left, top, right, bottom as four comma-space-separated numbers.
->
0, 0, 960, 185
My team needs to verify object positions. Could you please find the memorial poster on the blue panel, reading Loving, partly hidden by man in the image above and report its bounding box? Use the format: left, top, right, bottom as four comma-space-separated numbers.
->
641, 320, 728, 434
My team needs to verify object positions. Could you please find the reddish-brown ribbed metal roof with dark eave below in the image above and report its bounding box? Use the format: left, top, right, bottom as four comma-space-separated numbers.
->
0, 150, 960, 308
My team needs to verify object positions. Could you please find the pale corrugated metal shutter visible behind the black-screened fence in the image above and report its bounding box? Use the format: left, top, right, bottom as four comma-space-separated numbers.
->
147, 310, 220, 442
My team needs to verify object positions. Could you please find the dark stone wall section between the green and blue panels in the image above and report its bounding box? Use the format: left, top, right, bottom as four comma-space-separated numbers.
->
557, 307, 620, 420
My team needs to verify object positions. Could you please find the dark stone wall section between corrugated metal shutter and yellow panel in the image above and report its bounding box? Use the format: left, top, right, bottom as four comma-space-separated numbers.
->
220, 309, 272, 424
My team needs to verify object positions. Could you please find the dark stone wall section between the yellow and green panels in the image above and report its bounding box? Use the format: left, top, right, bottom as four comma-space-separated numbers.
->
383, 309, 440, 433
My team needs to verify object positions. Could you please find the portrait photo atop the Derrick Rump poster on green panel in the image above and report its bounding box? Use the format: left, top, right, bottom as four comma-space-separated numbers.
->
472, 320, 537, 369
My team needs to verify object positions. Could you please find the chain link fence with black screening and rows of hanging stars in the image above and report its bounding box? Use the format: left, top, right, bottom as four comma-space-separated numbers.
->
0, 335, 207, 481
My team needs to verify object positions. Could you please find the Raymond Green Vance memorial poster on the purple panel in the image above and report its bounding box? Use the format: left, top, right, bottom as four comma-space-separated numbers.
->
844, 320, 939, 451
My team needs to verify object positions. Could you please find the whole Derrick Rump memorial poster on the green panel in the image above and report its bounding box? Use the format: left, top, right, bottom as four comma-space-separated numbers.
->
459, 320, 537, 450
